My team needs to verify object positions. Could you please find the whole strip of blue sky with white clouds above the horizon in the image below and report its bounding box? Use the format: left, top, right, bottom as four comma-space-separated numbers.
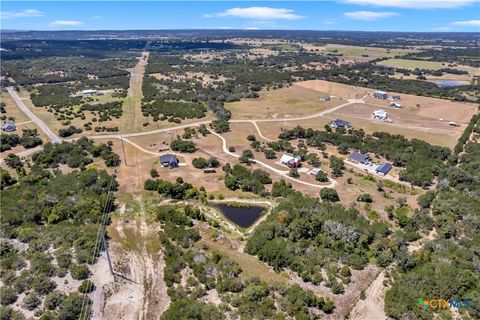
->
0, 0, 480, 32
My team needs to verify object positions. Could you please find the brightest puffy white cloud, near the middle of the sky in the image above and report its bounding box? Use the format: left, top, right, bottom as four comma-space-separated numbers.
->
203, 7, 303, 20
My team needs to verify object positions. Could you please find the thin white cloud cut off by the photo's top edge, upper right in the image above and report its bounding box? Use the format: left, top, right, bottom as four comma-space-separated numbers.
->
343, 0, 478, 9
